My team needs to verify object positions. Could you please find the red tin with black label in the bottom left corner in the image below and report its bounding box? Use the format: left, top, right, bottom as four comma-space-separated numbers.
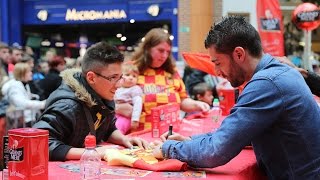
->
8, 128, 49, 180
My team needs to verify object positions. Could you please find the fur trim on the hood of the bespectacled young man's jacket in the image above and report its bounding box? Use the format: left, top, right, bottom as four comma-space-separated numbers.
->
60, 68, 97, 107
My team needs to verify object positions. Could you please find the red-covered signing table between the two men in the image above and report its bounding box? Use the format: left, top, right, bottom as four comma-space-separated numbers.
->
49, 114, 267, 180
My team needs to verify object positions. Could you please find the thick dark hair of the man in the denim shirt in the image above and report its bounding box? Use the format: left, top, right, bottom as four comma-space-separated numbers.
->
204, 16, 262, 57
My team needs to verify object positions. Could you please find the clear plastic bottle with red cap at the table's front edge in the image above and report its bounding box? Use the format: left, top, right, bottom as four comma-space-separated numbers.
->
80, 135, 101, 180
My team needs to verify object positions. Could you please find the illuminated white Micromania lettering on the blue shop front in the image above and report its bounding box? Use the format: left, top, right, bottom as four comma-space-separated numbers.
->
65, 8, 127, 21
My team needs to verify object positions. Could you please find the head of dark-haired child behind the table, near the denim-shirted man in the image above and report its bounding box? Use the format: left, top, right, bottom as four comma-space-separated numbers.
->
191, 83, 213, 107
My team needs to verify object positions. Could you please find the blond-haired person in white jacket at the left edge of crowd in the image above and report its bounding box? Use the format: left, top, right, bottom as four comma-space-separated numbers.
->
2, 62, 46, 127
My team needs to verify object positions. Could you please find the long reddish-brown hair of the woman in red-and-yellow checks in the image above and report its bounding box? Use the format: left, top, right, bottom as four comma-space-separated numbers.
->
132, 28, 175, 74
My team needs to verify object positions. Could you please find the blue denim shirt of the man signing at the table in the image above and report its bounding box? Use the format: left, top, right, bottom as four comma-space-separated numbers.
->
162, 54, 320, 179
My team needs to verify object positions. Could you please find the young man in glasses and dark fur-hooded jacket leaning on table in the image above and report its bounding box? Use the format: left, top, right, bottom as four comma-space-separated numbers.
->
33, 42, 148, 161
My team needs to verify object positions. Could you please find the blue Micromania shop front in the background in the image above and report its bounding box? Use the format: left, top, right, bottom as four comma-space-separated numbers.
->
0, 0, 178, 57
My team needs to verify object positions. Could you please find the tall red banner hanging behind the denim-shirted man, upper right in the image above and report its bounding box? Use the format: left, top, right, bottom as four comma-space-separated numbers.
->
257, 0, 284, 56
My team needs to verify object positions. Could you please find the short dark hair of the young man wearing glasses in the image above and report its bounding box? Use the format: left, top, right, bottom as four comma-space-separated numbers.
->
81, 42, 124, 74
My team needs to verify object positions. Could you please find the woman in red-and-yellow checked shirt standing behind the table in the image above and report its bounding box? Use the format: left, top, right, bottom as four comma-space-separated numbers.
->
116, 28, 210, 130
